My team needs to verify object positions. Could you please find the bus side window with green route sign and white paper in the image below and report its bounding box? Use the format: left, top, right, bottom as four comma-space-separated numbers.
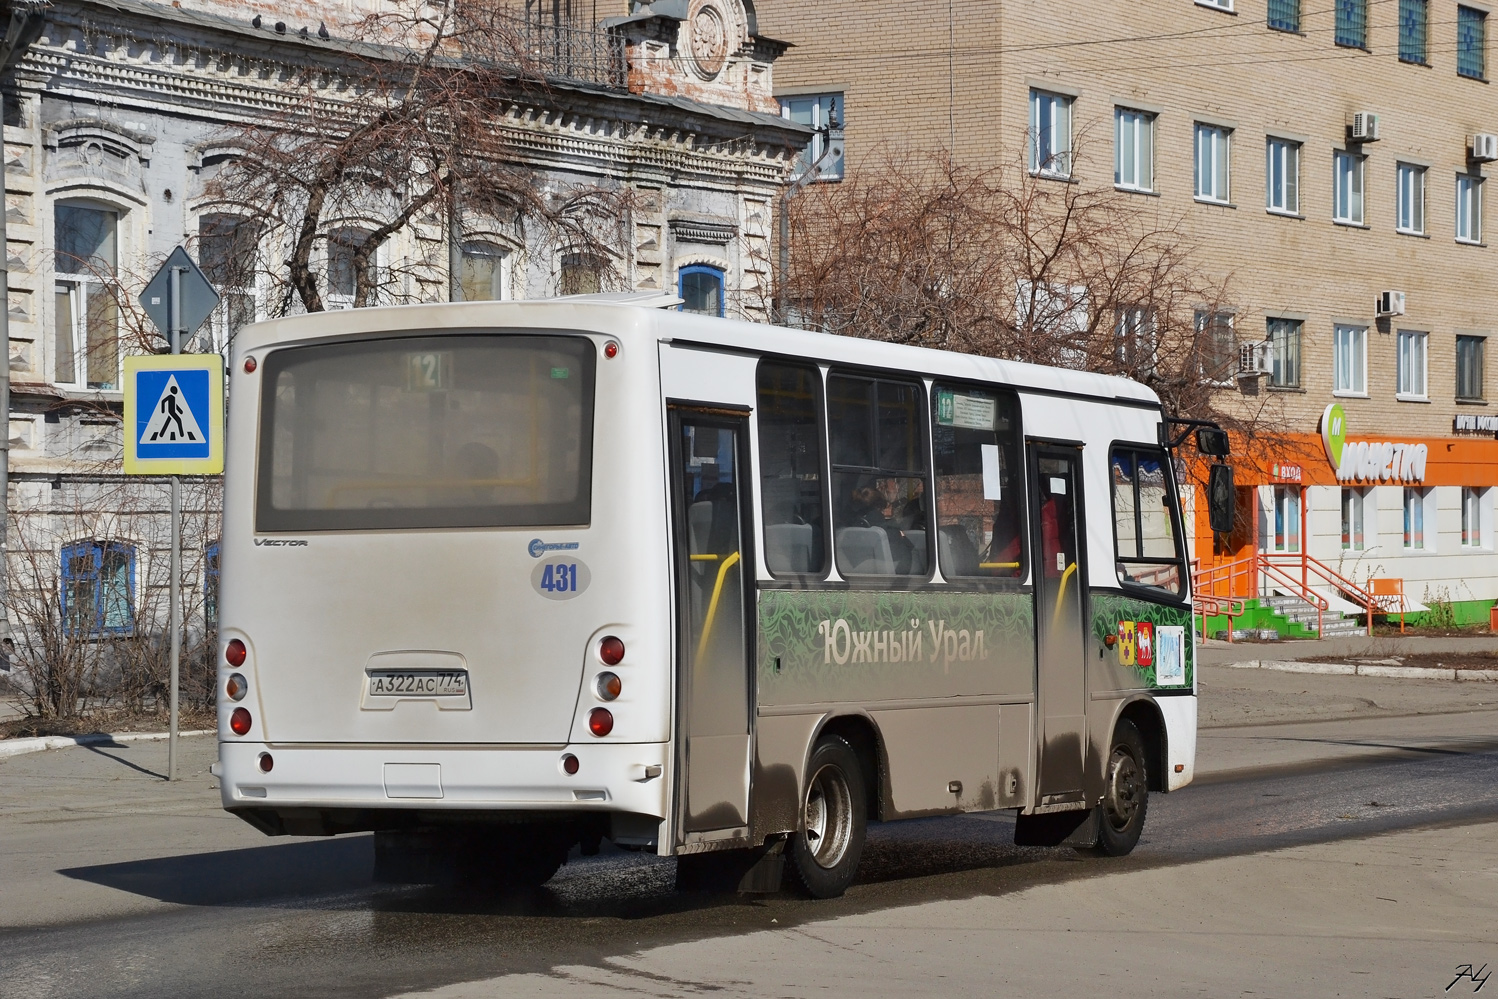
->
932, 382, 1025, 580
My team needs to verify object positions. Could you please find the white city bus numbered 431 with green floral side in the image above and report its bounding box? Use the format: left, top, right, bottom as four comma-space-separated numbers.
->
219, 297, 1225, 897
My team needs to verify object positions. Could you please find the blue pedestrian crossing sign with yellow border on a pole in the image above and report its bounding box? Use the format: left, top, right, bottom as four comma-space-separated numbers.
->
124, 353, 223, 475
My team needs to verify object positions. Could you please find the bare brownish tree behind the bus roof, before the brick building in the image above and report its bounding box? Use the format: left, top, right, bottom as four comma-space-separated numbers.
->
780, 143, 1275, 434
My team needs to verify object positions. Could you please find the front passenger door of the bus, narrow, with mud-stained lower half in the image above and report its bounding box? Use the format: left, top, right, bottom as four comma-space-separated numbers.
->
1029, 442, 1088, 806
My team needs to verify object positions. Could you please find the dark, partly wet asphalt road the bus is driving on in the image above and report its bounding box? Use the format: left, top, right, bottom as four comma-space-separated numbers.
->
0, 671, 1498, 999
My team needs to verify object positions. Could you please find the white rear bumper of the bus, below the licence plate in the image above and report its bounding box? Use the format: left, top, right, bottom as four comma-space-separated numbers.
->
219, 741, 670, 816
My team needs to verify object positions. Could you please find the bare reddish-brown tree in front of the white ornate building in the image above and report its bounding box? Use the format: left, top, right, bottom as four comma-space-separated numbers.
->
207, 0, 626, 315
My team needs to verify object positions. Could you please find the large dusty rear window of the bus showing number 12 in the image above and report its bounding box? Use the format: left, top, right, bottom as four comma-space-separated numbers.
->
255, 333, 595, 532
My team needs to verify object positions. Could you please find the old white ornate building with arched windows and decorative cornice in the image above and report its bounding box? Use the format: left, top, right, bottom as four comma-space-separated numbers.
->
0, 0, 809, 700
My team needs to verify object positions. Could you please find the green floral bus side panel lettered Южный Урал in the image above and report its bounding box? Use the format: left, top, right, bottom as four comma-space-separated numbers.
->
758, 590, 1035, 705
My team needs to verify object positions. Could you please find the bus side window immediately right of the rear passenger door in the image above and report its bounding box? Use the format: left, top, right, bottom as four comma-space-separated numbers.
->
758, 361, 827, 577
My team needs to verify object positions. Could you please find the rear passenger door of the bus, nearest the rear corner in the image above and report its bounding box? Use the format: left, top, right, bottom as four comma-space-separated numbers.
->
671, 407, 753, 842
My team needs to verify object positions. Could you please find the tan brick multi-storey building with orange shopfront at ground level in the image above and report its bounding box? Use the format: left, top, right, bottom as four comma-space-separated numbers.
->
758, 0, 1498, 620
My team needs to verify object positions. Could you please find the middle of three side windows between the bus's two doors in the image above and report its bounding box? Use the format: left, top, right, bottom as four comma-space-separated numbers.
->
827, 374, 932, 577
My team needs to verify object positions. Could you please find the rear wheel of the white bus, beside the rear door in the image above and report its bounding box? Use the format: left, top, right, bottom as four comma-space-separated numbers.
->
791, 735, 866, 899
